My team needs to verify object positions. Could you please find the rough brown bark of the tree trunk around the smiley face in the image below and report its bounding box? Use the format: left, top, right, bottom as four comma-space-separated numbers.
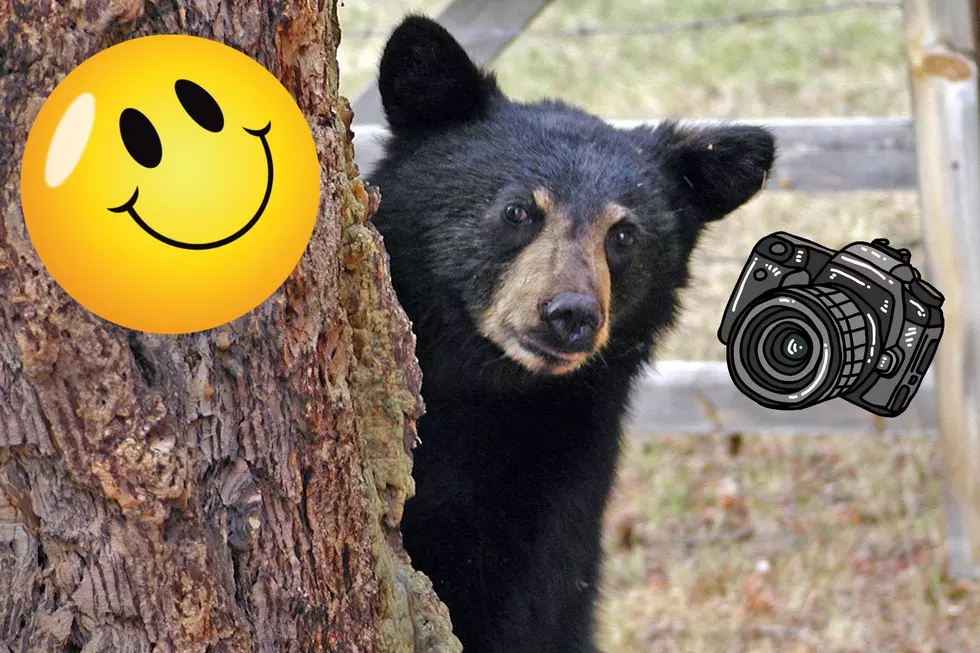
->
0, 0, 460, 653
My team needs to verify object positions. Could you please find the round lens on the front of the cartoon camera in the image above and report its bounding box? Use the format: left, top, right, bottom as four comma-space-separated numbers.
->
727, 286, 881, 408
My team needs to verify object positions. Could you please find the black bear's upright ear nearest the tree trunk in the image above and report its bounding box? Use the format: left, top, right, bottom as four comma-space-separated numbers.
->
378, 15, 500, 133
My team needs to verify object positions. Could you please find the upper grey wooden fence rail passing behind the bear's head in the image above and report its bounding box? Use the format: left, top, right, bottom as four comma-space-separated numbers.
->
353, 115, 918, 192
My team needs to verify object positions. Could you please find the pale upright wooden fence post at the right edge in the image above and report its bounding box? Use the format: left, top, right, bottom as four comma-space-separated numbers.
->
905, 0, 980, 576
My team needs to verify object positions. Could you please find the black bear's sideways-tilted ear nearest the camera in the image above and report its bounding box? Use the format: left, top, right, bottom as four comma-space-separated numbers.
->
654, 121, 776, 222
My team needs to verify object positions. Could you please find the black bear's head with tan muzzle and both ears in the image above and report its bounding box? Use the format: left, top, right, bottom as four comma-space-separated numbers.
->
370, 16, 775, 388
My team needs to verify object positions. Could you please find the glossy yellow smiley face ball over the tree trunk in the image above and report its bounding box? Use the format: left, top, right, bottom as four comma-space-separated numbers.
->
21, 35, 320, 333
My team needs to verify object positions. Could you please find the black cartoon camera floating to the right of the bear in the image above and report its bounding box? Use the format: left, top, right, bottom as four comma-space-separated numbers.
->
718, 232, 944, 417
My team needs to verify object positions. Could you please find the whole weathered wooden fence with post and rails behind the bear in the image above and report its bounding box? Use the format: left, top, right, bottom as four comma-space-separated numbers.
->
353, 0, 980, 577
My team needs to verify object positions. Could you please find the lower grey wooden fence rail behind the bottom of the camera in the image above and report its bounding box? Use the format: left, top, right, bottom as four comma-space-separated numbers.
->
624, 361, 937, 438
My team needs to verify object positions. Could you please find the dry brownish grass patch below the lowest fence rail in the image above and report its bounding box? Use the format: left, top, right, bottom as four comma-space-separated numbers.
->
602, 436, 980, 653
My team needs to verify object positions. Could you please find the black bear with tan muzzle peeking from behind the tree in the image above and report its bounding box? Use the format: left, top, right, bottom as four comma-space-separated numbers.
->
369, 16, 775, 653
